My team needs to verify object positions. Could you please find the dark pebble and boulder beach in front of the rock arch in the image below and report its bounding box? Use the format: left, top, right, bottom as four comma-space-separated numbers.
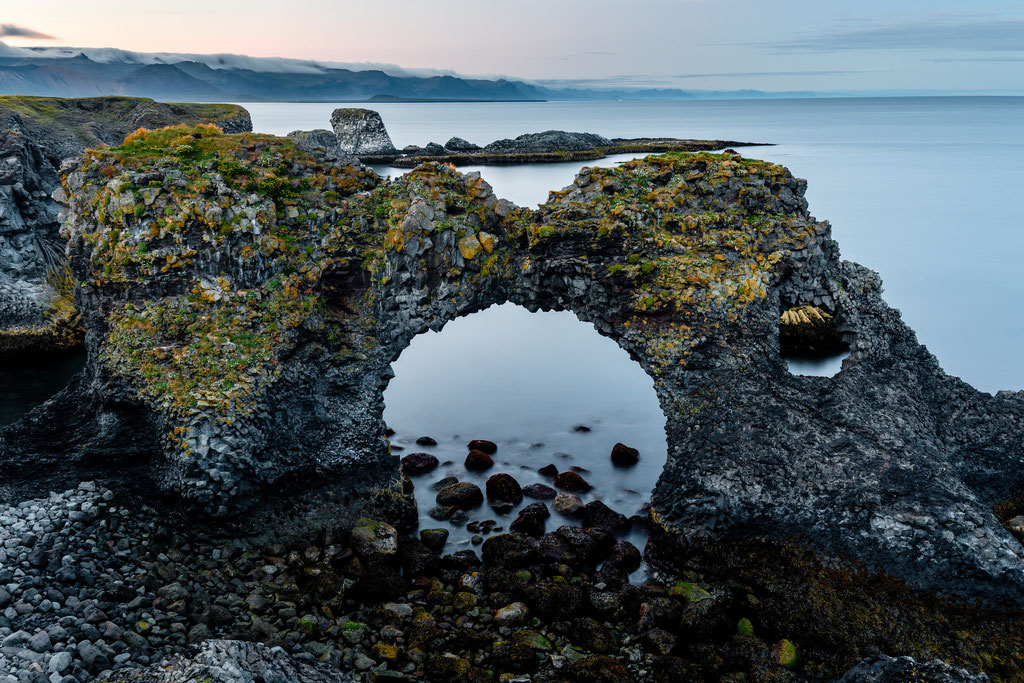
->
0, 482, 1007, 683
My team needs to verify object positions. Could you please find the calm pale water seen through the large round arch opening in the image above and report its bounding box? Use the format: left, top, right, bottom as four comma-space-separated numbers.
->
384, 304, 667, 577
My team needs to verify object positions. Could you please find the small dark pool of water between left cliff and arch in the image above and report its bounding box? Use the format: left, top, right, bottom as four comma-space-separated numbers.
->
0, 351, 85, 426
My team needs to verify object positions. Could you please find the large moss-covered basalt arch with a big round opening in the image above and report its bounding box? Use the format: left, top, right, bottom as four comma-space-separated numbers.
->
0, 122, 1024, 606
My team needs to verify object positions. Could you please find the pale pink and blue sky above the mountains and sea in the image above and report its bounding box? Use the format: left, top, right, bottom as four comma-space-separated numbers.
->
0, 0, 1024, 91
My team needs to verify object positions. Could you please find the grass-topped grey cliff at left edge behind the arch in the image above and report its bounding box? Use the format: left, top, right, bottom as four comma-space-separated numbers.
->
0, 96, 252, 356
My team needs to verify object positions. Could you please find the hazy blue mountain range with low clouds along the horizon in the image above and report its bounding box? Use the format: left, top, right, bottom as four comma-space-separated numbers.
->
0, 42, 812, 101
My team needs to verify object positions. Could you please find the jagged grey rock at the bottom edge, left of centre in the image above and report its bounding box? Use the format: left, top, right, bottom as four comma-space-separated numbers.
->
109, 640, 355, 683
